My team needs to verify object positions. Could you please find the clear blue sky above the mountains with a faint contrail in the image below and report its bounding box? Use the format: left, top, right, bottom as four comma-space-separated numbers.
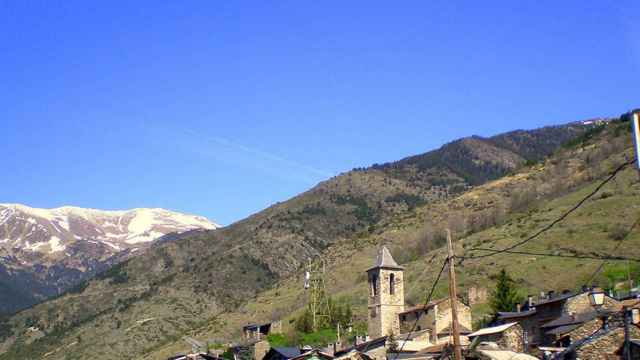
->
0, 0, 640, 224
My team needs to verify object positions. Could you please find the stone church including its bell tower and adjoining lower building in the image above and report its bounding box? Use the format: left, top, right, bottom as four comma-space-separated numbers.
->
367, 246, 471, 344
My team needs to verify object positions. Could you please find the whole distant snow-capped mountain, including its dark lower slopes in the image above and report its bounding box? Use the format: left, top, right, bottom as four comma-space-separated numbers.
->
0, 204, 220, 313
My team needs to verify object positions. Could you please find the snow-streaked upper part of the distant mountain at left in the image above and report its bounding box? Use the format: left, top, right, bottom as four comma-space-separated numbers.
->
0, 204, 220, 254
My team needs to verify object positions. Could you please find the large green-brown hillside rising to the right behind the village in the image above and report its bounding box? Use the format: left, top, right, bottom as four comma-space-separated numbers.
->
0, 116, 637, 359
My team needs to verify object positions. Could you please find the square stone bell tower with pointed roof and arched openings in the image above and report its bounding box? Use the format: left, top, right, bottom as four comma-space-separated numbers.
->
367, 246, 404, 339
